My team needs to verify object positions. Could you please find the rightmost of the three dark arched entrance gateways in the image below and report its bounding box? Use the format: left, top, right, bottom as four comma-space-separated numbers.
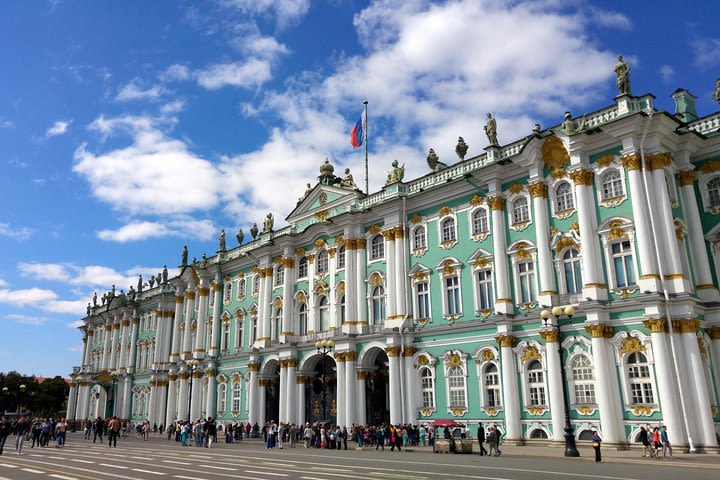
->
358, 347, 390, 425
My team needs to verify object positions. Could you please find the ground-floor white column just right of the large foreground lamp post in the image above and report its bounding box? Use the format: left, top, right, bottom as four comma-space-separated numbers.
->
585, 324, 627, 444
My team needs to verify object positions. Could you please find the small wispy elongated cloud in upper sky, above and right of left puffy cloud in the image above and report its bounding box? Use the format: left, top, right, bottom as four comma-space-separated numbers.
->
195, 58, 272, 90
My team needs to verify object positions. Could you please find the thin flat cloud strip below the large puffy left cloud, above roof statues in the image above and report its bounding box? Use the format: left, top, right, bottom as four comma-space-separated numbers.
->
97, 219, 217, 242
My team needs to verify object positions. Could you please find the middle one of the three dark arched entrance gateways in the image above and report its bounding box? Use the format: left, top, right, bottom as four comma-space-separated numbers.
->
304, 348, 338, 424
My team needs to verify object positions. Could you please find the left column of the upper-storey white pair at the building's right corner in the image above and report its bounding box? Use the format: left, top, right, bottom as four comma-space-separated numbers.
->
623, 160, 660, 291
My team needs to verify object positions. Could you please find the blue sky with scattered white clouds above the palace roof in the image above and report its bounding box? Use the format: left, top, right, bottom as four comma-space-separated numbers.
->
0, 0, 720, 376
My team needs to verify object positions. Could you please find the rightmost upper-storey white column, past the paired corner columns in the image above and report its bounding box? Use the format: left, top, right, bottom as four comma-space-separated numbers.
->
678, 170, 718, 299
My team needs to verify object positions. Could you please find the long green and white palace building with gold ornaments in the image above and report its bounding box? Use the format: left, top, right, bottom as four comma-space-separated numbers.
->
67, 81, 720, 450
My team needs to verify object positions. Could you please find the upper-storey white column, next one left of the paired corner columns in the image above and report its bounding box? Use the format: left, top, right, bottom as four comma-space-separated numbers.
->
570, 170, 607, 300
